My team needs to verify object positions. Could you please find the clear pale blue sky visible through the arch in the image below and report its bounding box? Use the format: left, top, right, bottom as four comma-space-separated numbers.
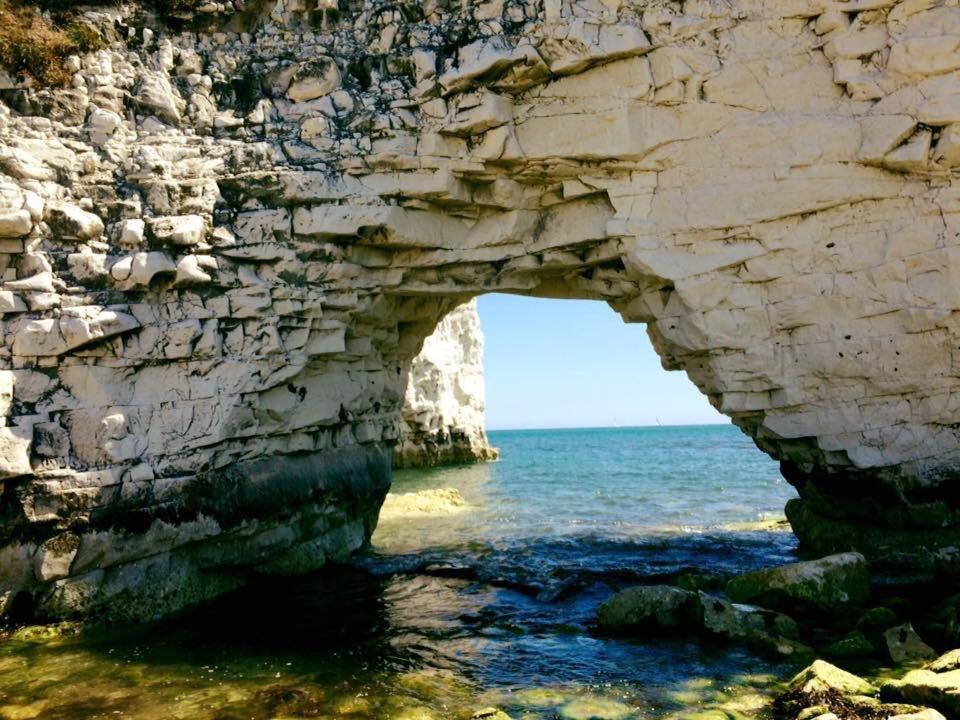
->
479, 295, 729, 430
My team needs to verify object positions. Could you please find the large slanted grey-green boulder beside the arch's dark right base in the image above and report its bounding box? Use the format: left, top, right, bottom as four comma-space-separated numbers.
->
727, 553, 870, 611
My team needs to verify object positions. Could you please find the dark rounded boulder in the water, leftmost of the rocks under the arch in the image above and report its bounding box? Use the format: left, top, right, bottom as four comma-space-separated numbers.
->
597, 585, 703, 630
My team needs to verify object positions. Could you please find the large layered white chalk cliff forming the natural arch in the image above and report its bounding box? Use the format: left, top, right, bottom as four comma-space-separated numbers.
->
0, 0, 960, 617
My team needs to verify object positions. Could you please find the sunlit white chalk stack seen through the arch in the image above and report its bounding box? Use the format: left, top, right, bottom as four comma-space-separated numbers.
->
393, 302, 497, 467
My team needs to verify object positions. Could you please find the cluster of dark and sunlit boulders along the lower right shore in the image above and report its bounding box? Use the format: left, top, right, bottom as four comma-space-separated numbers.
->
597, 553, 960, 720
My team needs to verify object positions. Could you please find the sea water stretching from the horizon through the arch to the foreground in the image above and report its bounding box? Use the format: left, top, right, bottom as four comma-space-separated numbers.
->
0, 426, 795, 720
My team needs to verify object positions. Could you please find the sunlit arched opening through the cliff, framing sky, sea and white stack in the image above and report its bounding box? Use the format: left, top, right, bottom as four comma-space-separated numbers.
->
381, 295, 793, 536
